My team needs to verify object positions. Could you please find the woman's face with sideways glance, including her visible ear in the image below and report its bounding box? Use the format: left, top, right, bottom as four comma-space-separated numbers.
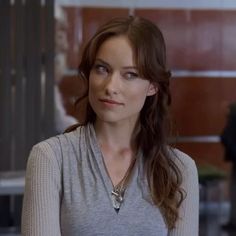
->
89, 36, 156, 124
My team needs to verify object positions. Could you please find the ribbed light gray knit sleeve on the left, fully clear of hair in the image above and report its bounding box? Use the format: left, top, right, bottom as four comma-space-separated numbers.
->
22, 142, 61, 236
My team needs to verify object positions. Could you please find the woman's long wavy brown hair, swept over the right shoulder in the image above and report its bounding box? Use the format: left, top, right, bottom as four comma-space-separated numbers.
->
67, 17, 184, 229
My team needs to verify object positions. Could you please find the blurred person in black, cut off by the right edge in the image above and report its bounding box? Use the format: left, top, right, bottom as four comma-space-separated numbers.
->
221, 103, 236, 231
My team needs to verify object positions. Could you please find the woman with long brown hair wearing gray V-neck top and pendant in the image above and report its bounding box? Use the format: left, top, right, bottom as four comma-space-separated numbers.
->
22, 17, 199, 236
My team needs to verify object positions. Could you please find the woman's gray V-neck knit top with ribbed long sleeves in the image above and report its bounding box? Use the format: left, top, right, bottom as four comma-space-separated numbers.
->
22, 124, 199, 236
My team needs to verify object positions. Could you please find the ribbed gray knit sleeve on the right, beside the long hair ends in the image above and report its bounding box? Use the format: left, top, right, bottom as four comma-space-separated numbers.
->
168, 151, 199, 236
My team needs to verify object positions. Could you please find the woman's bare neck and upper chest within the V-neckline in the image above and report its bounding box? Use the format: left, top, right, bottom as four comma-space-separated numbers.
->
94, 120, 137, 186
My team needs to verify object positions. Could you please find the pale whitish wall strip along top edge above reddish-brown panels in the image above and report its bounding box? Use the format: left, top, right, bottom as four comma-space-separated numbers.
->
55, 0, 236, 10
